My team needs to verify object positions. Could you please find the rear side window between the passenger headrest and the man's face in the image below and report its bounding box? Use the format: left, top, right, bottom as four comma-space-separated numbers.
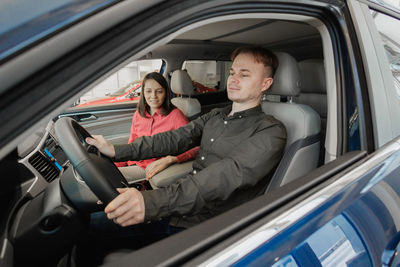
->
182, 60, 232, 94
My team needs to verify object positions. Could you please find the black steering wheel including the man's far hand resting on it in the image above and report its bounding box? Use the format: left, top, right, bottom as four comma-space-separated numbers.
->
54, 117, 128, 208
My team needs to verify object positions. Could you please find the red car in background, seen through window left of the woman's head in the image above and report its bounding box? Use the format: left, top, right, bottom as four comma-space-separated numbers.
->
77, 81, 142, 107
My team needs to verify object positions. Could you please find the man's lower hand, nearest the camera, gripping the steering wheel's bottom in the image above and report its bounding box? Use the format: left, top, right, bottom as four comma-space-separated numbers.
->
104, 188, 145, 227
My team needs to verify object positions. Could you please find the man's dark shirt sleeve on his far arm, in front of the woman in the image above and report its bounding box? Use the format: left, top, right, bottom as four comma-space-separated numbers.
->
114, 112, 213, 161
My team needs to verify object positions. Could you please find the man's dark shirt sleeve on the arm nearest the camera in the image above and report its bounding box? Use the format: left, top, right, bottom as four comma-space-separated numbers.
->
142, 124, 286, 220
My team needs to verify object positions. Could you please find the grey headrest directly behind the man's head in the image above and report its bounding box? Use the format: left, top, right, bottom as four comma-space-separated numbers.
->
266, 52, 300, 96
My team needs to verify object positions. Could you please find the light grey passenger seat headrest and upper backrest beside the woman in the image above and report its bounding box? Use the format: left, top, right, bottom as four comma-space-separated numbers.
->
171, 70, 201, 120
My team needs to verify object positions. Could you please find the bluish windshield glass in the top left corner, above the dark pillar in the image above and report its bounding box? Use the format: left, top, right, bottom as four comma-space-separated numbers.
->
0, 0, 116, 60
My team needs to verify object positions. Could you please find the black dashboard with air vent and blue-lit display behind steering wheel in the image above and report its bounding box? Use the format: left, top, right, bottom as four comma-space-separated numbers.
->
0, 121, 91, 266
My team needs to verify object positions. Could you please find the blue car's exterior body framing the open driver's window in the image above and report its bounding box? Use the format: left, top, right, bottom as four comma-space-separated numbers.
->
0, 0, 400, 267
